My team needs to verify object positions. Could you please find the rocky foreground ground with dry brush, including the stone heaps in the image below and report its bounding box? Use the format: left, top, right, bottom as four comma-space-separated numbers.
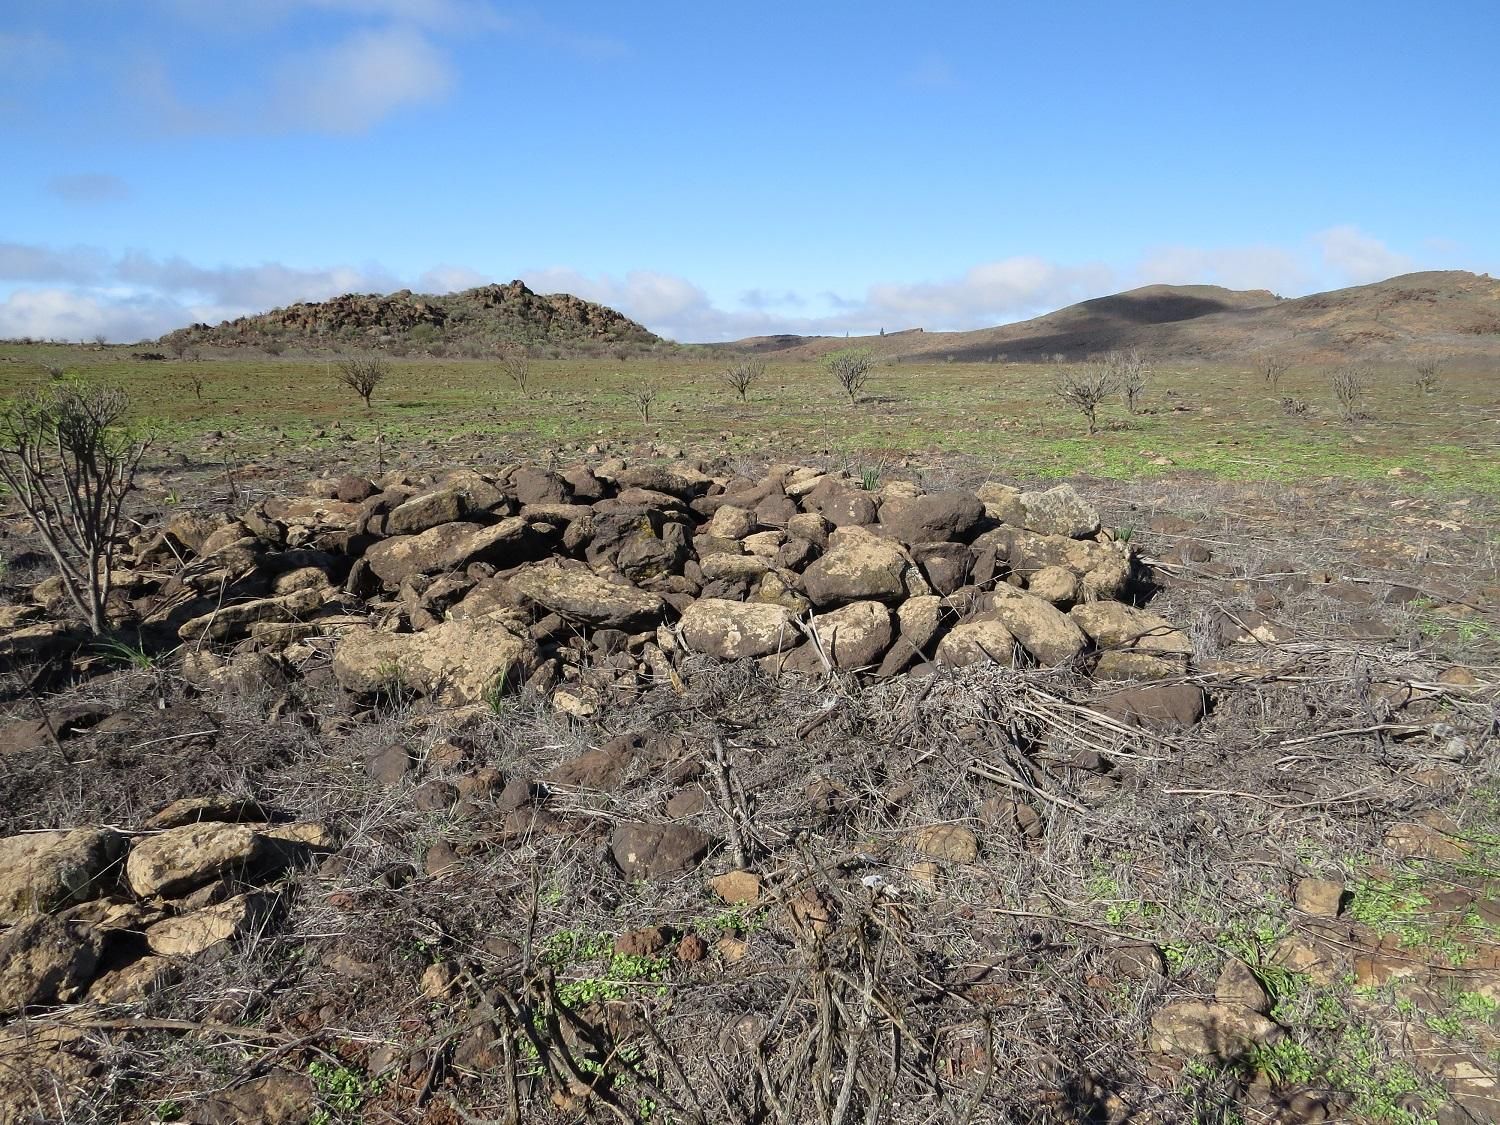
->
0, 447, 1500, 1125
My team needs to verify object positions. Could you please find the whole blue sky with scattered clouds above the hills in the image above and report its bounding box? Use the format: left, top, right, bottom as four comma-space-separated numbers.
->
0, 0, 1500, 341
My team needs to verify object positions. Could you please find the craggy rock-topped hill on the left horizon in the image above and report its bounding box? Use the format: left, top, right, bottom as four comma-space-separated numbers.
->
161, 281, 669, 356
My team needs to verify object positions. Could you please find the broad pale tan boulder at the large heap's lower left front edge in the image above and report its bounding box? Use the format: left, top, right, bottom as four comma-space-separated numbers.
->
333, 618, 537, 704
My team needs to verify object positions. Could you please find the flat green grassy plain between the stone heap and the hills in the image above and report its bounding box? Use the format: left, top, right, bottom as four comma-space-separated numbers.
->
0, 345, 1500, 494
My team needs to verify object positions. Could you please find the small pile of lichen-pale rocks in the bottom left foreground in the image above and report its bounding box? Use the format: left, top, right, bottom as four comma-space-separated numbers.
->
0, 798, 333, 1016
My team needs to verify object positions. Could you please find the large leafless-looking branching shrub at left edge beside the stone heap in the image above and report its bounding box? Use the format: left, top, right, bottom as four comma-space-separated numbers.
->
0, 380, 147, 633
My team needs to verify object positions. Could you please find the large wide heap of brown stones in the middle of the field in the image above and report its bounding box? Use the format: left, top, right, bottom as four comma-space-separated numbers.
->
11, 461, 1191, 714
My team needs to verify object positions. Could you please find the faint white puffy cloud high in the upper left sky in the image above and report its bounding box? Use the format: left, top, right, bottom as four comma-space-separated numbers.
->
267, 27, 455, 134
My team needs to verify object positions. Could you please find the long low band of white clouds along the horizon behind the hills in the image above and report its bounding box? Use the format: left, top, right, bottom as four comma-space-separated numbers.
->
0, 226, 1464, 342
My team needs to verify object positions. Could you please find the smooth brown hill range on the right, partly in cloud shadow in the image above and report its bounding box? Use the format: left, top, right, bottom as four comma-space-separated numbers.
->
728, 270, 1500, 363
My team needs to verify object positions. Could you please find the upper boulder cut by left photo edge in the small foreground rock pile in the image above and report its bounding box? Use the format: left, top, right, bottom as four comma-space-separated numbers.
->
0, 828, 126, 923
